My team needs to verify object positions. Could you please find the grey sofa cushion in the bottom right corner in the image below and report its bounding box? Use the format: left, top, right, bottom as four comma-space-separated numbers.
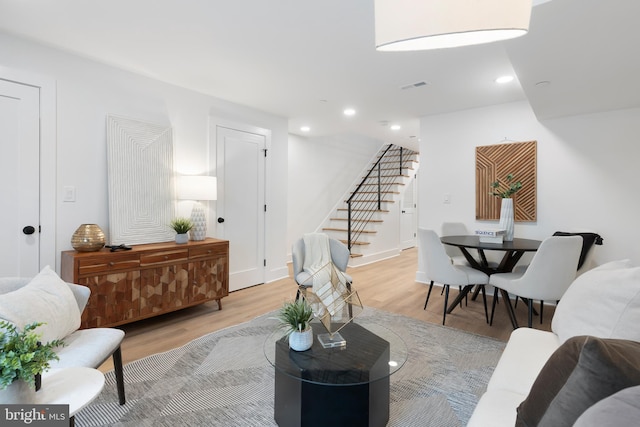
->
573, 386, 640, 427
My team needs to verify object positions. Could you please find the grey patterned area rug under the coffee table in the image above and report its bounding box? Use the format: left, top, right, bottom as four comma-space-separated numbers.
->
76, 308, 505, 427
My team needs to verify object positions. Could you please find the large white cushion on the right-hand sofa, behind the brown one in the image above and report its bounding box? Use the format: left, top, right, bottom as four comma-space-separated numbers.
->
551, 260, 640, 343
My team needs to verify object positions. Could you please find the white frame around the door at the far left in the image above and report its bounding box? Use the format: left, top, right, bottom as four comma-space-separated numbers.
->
0, 66, 60, 271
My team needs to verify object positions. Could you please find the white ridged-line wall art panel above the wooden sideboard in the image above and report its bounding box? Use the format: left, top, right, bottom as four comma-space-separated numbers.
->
107, 115, 175, 245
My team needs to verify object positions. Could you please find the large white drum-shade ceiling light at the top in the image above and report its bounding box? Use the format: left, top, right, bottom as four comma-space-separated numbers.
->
375, 0, 532, 51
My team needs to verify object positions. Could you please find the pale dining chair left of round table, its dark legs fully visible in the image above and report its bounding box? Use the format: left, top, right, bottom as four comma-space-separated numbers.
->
418, 228, 489, 325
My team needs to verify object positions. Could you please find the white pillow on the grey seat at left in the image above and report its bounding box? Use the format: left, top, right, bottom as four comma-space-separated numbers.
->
0, 266, 80, 342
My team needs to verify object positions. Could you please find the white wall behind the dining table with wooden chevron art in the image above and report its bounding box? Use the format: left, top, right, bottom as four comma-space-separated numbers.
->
417, 102, 640, 280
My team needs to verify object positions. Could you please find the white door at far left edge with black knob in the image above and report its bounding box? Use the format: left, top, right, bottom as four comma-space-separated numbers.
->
0, 80, 40, 277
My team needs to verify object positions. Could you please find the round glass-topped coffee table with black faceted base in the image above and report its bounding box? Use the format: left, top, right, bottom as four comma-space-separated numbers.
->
264, 319, 407, 427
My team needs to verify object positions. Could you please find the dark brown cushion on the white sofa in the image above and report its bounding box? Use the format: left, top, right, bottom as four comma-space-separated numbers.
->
516, 336, 640, 427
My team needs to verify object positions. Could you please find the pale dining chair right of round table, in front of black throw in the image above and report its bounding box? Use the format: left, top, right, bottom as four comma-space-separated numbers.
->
489, 236, 582, 328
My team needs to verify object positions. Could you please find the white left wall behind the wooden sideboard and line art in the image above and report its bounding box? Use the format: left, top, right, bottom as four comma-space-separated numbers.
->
0, 33, 288, 280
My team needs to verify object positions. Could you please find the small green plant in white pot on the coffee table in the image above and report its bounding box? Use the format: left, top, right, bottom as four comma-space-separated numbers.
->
278, 298, 313, 351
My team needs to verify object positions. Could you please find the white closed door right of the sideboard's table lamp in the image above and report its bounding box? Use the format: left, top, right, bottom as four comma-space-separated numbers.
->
212, 125, 266, 291
